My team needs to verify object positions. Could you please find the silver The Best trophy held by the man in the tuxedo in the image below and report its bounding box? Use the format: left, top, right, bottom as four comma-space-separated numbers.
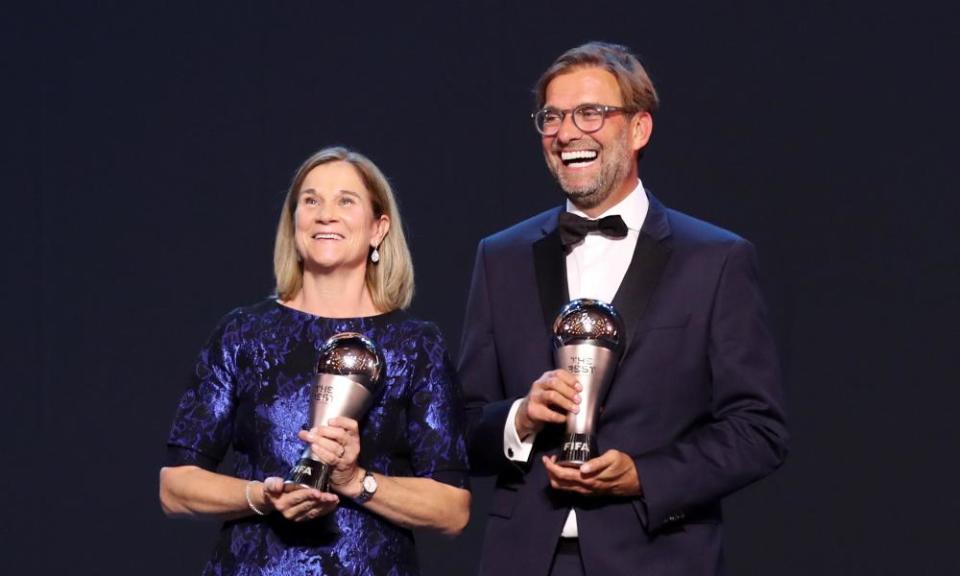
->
553, 298, 624, 467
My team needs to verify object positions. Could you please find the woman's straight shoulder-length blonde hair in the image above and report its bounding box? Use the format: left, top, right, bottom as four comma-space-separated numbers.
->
273, 146, 413, 312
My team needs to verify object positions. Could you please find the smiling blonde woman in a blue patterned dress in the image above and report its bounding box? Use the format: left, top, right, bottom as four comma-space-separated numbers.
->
160, 148, 470, 574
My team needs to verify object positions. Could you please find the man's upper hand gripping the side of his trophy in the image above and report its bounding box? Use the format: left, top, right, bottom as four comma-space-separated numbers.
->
514, 369, 583, 440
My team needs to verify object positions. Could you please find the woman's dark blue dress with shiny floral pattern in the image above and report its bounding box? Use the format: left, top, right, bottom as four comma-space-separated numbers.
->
166, 300, 468, 576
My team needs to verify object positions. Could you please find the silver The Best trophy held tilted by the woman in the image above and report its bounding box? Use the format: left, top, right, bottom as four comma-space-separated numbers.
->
286, 332, 386, 492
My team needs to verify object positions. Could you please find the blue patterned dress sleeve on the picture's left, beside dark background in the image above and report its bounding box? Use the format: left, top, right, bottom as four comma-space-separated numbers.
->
166, 311, 241, 471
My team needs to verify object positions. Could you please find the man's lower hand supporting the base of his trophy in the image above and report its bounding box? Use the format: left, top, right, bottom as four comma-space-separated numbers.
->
543, 450, 643, 496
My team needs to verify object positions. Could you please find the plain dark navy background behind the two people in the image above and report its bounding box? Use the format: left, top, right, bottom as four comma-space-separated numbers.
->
0, 0, 960, 575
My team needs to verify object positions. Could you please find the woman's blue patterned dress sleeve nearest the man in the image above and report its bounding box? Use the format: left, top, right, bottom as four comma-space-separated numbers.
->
407, 323, 469, 488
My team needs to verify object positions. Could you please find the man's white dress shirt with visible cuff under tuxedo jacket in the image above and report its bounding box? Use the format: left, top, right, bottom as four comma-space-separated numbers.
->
503, 180, 650, 538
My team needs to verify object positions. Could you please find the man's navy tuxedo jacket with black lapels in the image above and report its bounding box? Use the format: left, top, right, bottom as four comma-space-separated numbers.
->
458, 192, 787, 576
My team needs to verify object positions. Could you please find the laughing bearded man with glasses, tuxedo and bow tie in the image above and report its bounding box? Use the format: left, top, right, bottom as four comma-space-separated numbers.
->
459, 43, 787, 576
